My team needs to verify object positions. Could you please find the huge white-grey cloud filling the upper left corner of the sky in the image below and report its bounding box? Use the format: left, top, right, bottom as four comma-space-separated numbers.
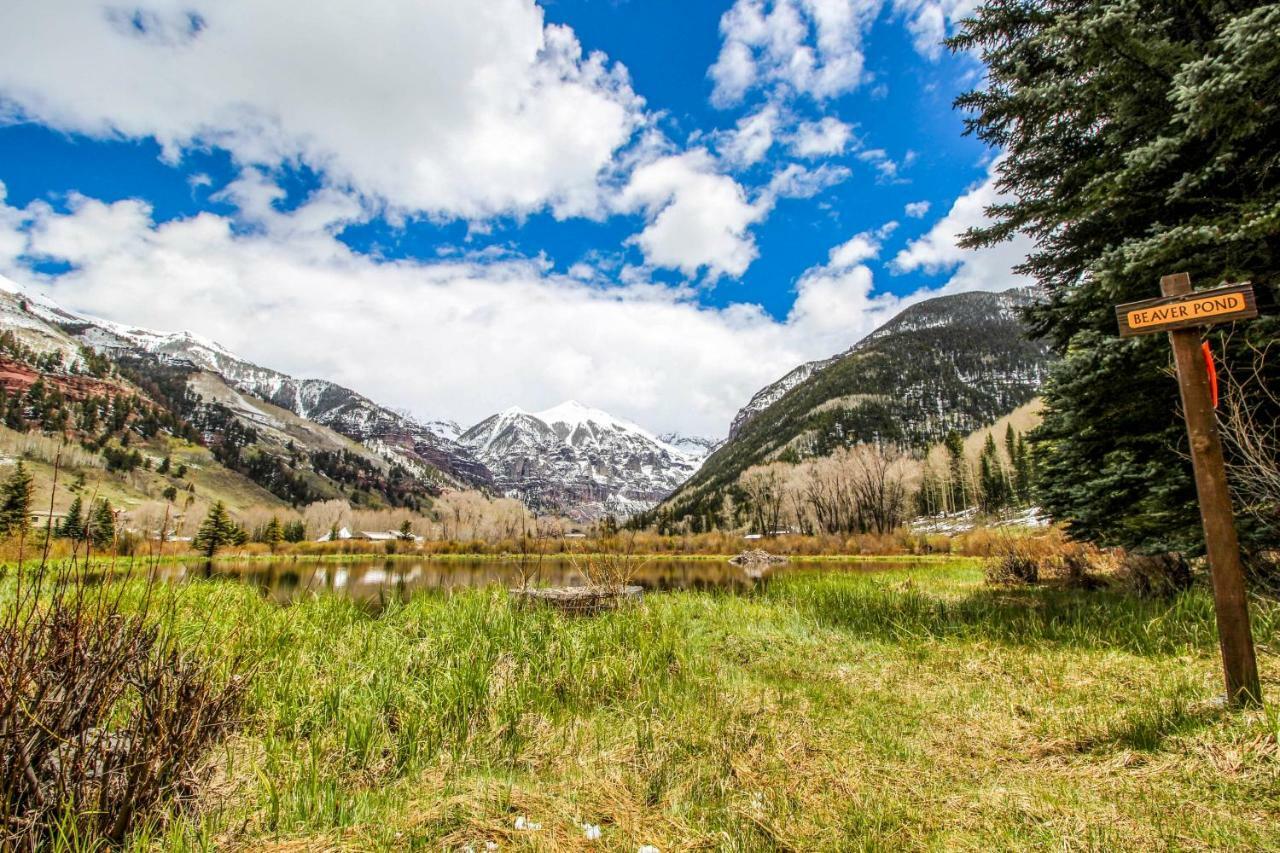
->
0, 0, 645, 218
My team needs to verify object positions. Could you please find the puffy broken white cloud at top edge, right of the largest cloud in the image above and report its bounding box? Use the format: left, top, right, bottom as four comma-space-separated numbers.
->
708, 0, 881, 106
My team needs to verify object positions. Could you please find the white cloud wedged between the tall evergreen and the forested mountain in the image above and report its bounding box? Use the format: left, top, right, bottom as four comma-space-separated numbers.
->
891, 159, 1033, 292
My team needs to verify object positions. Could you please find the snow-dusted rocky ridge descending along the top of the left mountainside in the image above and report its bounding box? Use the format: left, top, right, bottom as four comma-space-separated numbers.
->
12, 284, 493, 487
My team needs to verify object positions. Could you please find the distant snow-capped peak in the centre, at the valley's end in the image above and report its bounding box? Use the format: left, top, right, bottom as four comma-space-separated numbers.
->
458, 401, 705, 520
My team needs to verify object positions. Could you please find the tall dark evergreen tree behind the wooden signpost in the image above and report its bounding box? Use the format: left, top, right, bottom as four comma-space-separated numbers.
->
950, 0, 1280, 553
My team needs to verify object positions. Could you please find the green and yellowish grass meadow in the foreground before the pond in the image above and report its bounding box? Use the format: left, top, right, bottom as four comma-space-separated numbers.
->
17, 562, 1280, 850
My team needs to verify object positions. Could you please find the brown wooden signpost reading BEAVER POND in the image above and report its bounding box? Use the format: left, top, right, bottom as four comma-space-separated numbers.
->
1116, 273, 1262, 706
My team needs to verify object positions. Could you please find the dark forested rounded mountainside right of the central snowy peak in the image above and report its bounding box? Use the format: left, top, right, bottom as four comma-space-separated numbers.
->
645, 291, 1048, 529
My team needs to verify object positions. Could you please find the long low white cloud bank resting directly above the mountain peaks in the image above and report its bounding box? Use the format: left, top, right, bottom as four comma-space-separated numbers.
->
0, 175, 1029, 435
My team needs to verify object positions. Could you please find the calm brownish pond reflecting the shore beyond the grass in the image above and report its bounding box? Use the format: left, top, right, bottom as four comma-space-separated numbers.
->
145, 557, 922, 607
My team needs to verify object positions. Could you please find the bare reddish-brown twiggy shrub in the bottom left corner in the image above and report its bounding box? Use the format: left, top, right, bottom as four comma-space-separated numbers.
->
0, 565, 243, 849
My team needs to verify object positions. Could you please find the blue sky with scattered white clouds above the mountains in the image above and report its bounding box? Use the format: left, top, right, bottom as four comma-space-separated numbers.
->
0, 0, 1025, 435
